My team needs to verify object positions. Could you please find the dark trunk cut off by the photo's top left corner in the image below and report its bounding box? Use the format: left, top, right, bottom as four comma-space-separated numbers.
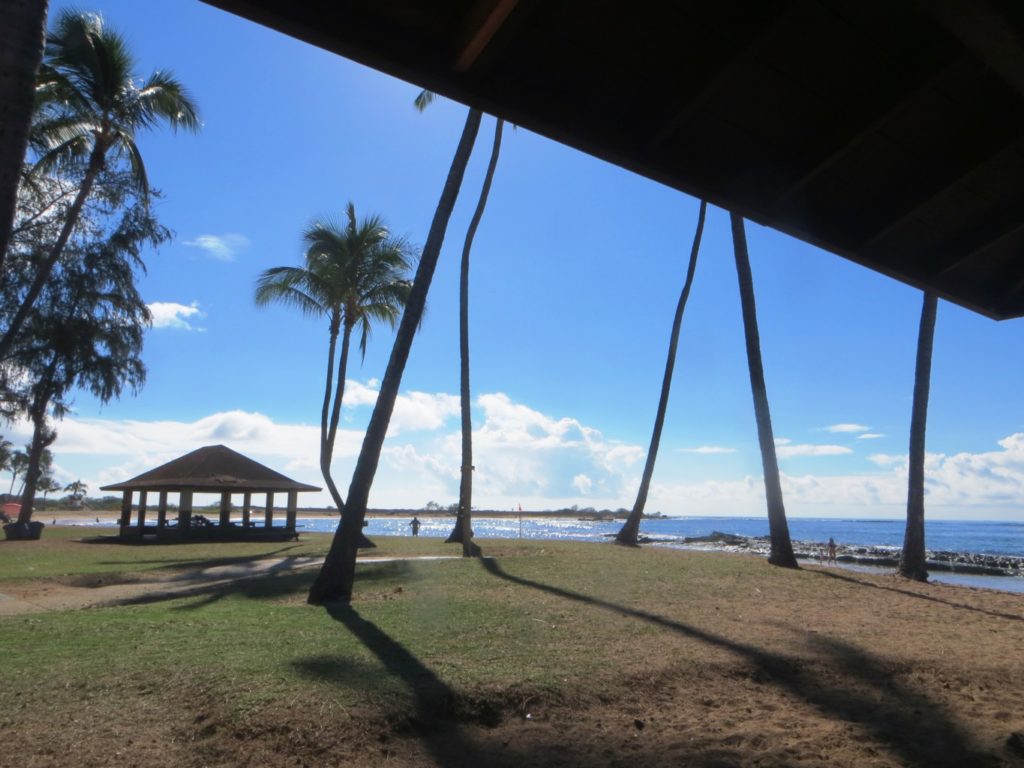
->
0, 0, 47, 274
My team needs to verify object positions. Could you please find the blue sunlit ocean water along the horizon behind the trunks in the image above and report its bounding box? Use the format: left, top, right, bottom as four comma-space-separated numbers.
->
290, 517, 1024, 557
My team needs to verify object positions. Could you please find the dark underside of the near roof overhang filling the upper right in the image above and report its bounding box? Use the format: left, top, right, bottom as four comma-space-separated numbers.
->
206, 0, 1024, 318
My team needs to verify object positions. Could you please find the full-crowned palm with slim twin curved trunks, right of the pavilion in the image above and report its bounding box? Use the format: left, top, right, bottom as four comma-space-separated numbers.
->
256, 203, 416, 524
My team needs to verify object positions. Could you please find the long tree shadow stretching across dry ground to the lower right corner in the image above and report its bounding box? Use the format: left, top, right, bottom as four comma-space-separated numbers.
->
480, 558, 1001, 768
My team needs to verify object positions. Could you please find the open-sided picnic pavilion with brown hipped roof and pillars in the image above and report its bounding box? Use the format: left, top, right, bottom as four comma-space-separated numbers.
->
100, 445, 321, 541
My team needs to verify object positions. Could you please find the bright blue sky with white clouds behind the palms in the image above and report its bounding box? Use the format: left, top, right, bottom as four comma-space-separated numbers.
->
12, 0, 1024, 521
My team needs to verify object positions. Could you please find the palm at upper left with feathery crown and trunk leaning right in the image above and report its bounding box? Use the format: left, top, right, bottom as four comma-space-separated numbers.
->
0, 9, 200, 359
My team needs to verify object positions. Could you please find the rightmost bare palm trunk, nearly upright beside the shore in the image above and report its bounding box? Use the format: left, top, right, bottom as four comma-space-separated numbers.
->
899, 292, 939, 582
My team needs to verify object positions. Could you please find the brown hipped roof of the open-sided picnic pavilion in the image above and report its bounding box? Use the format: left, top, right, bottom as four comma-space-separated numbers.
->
100, 445, 319, 493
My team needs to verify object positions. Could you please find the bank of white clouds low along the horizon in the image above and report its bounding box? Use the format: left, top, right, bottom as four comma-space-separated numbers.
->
10, 381, 1024, 520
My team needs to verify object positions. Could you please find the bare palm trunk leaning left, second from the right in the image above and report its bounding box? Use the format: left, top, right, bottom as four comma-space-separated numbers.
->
729, 212, 798, 568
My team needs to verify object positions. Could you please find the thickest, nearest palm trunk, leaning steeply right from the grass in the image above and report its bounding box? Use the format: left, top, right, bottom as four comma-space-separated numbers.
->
307, 110, 481, 605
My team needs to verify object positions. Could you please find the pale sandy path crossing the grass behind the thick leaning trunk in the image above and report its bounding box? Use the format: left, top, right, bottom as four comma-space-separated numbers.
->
0, 556, 456, 615
